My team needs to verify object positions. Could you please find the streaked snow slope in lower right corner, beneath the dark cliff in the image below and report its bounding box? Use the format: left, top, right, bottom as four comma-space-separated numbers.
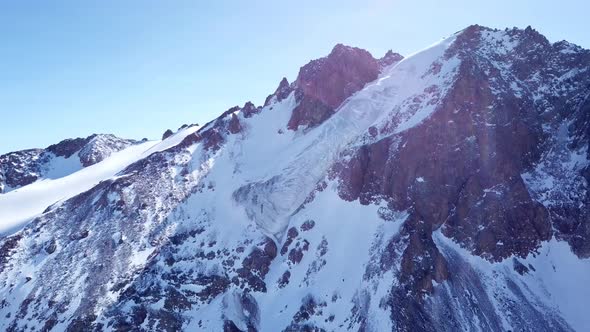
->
432, 233, 590, 331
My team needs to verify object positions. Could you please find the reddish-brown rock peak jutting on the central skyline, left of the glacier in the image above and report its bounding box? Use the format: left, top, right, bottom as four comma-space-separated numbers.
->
287, 44, 380, 130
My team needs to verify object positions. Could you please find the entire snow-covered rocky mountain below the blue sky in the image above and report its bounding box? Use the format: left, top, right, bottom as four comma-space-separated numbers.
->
0, 25, 590, 331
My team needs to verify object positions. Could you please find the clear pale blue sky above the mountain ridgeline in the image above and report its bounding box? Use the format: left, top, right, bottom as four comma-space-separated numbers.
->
0, 0, 590, 154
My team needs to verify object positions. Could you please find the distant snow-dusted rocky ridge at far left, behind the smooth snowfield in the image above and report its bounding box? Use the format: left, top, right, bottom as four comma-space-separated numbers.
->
0, 134, 138, 193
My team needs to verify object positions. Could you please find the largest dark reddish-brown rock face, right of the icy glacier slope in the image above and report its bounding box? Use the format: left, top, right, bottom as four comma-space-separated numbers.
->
335, 26, 590, 280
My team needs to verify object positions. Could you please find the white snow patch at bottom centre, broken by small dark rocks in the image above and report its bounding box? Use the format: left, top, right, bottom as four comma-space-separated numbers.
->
257, 183, 407, 331
